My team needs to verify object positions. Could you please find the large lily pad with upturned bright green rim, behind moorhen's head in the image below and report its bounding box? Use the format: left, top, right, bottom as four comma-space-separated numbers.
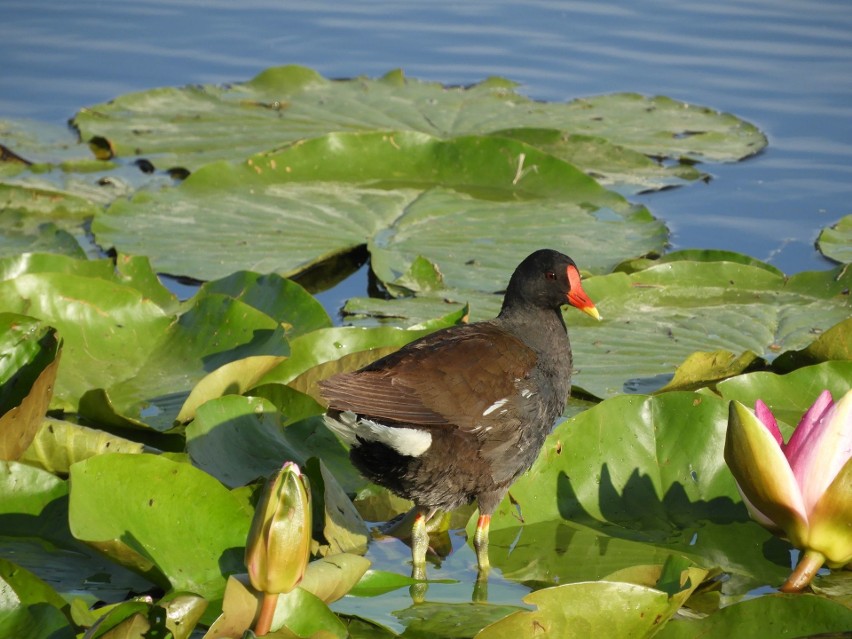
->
93, 132, 667, 284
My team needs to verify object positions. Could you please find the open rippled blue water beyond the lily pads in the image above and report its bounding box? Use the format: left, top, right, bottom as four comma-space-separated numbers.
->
0, 0, 852, 298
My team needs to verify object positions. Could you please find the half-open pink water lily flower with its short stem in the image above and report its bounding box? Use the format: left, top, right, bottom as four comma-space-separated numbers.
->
725, 390, 852, 592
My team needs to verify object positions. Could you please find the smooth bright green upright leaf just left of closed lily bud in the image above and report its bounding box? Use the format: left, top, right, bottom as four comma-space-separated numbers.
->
68, 453, 252, 600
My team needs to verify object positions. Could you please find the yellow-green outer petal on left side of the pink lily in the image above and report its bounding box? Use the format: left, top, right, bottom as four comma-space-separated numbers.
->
725, 401, 808, 547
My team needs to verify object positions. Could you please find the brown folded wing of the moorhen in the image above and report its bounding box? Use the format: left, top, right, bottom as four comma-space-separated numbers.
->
320, 322, 536, 431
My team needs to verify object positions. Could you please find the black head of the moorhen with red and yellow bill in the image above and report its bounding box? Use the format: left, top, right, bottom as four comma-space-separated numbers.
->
501, 249, 600, 319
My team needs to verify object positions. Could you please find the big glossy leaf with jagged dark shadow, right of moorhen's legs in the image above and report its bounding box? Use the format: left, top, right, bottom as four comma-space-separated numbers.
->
486, 392, 789, 594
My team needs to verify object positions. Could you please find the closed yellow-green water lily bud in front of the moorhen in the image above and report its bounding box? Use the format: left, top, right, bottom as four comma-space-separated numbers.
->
245, 462, 311, 593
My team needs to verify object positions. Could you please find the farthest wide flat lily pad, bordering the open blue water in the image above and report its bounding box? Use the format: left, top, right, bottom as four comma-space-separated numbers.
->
72, 66, 766, 170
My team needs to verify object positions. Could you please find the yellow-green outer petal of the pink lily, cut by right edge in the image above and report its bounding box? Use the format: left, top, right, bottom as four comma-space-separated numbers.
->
808, 459, 852, 568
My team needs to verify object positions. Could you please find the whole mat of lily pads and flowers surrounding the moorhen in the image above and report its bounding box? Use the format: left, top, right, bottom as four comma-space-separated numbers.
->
0, 66, 852, 639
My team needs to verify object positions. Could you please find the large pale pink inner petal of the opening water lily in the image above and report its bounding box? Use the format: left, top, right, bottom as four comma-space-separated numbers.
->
785, 390, 852, 513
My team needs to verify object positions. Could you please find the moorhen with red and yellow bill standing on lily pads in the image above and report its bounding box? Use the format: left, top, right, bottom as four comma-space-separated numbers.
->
320, 249, 600, 571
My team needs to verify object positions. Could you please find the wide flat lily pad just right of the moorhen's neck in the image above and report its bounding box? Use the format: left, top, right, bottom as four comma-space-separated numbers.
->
566, 262, 852, 397
